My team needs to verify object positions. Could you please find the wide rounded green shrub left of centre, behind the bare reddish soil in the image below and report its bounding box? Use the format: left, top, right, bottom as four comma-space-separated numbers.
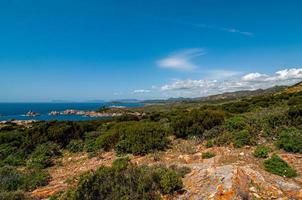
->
96, 122, 169, 155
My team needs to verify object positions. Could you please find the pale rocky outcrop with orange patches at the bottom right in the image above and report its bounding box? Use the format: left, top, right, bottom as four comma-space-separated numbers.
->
176, 153, 302, 200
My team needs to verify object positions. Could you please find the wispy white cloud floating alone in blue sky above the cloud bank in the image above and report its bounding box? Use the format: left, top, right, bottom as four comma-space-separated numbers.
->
157, 48, 205, 71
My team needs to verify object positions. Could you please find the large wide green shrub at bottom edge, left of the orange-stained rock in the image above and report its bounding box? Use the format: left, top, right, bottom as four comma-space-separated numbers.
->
58, 159, 182, 200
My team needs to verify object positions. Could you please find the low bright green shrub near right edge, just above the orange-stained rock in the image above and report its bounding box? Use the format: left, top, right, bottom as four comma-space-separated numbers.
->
264, 154, 297, 178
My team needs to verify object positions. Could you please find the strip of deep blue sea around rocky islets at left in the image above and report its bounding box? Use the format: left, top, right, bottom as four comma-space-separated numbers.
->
0, 103, 143, 121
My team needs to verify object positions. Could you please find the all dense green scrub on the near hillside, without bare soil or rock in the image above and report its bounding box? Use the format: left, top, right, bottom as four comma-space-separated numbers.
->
0, 83, 302, 200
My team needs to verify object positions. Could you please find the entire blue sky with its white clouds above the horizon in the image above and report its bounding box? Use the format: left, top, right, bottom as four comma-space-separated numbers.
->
0, 0, 302, 102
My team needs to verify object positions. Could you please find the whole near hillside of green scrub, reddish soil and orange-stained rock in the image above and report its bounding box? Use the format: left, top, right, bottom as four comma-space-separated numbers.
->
0, 83, 302, 200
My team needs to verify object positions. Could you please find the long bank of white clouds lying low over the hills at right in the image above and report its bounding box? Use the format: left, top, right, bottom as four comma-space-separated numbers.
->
160, 68, 302, 97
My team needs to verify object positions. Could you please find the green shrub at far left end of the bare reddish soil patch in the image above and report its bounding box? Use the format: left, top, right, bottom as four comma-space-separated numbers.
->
27, 142, 61, 169
